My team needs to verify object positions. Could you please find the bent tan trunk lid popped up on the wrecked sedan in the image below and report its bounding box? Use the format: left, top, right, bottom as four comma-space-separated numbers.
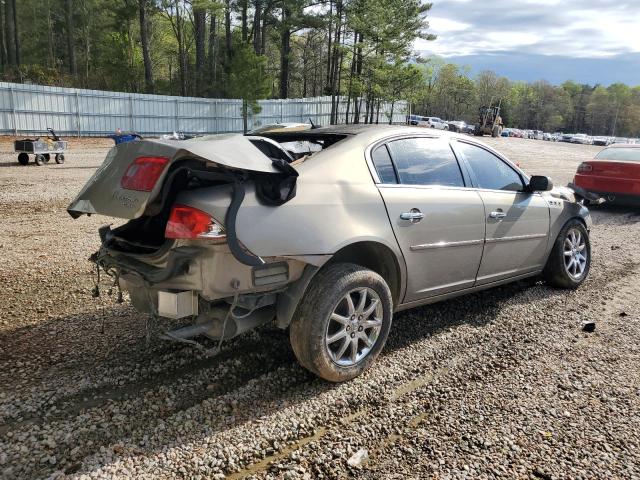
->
67, 134, 282, 220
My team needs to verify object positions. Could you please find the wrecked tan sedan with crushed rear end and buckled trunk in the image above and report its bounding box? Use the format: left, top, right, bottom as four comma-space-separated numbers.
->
68, 126, 591, 381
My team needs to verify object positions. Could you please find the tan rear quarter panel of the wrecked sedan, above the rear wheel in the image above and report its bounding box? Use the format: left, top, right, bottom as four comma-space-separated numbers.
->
177, 134, 404, 265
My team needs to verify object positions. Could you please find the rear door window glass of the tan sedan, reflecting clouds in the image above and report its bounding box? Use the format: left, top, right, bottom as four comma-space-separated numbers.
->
388, 138, 464, 187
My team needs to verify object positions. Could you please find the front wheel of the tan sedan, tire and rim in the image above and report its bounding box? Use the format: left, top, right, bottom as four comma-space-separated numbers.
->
543, 219, 591, 289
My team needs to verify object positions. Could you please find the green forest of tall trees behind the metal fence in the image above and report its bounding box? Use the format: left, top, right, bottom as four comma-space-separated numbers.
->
0, 0, 640, 136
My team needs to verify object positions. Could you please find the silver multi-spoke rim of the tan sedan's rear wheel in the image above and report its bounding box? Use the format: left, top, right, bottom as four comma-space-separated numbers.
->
325, 287, 383, 367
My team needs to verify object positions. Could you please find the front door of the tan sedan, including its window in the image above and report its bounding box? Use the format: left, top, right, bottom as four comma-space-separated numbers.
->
455, 141, 549, 285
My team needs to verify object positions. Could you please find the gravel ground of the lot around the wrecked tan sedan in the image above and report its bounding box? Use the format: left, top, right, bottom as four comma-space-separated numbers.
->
0, 138, 640, 479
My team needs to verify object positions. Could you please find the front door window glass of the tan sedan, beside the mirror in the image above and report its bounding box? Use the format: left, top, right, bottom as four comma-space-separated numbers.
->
458, 142, 524, 192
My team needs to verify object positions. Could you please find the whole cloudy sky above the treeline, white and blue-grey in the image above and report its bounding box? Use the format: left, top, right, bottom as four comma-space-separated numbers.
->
415, 0, 640, 85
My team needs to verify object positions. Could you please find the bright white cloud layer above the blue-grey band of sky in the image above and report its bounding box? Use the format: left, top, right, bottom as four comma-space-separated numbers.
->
415, 0, 640, 58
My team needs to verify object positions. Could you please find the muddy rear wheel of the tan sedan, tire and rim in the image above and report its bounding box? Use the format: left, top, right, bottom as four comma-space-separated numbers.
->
289, 263, 393, 382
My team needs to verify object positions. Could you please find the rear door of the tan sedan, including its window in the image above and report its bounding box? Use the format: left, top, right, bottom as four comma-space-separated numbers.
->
371, 137, 485, 302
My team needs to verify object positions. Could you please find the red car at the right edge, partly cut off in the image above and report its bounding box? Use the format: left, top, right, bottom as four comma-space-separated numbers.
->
573, 144, 640, 203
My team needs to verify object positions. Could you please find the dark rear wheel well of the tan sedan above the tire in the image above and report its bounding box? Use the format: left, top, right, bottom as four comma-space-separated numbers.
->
326, 242, 401, 305
